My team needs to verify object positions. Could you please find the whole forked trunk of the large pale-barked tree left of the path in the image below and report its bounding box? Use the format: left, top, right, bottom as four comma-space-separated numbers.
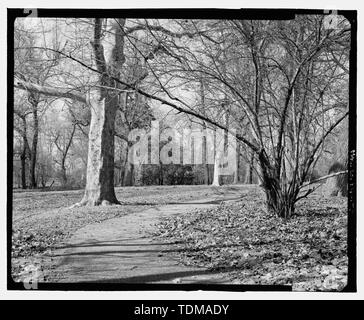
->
76, 18, 125, 206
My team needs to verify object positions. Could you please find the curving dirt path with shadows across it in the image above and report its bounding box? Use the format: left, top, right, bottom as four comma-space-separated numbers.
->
50, 187, 241, 283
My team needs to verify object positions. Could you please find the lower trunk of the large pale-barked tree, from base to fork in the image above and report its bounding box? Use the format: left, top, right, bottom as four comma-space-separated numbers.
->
80, 95, 119, 206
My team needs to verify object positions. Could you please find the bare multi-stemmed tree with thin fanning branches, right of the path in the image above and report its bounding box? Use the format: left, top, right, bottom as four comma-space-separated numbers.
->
140, 16, 350, 218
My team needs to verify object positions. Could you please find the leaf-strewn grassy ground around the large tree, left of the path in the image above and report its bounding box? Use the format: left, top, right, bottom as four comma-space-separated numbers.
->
11, 186, 225, 281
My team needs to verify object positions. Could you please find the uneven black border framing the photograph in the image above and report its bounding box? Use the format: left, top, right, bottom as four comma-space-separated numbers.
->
7, 8, 357, 292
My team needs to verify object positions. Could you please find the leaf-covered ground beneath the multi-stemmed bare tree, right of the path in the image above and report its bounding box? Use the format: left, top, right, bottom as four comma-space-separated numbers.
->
157, 188, 347, 291
